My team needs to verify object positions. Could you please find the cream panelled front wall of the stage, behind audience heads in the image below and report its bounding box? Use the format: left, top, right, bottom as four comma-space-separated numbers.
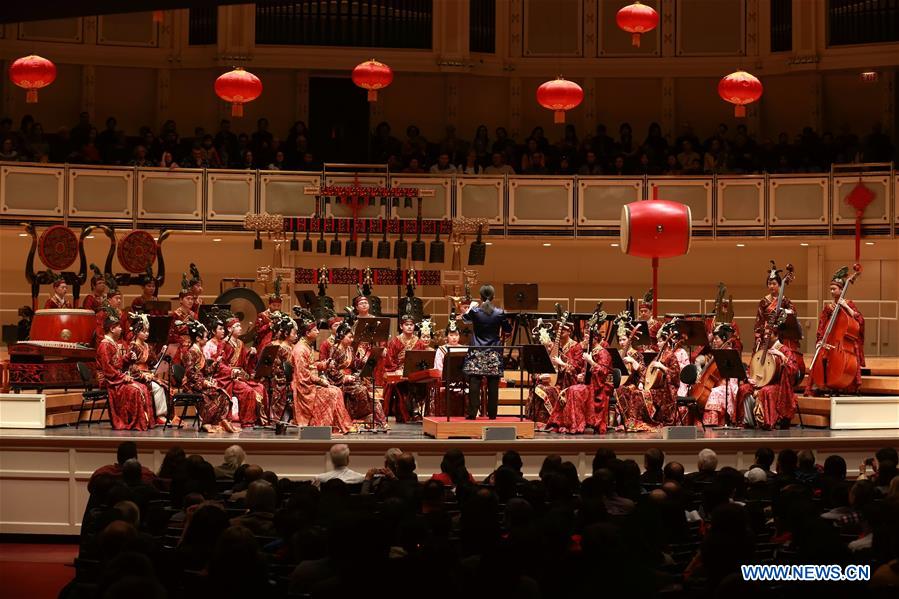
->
0, 433, 895, 534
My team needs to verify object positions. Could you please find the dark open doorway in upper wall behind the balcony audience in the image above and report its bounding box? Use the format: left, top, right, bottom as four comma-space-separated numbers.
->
309, 77, 369, 162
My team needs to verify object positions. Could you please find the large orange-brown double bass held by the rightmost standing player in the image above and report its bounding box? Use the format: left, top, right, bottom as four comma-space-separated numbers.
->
811, 264, 862, 390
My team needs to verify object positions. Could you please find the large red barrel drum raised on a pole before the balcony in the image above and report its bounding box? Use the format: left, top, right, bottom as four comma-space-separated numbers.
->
621, 200, 693, 258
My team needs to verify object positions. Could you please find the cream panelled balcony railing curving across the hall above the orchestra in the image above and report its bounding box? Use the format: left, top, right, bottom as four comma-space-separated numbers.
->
0, 162, 899, 239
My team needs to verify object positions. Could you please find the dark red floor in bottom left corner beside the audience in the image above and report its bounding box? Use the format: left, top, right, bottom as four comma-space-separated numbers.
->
0, 543, 78, 599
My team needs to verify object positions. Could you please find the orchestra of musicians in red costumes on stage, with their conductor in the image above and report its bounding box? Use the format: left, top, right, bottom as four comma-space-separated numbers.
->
44, 261, 864, 434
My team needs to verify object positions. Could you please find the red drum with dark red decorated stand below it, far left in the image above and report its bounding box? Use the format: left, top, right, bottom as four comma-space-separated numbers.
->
9, 308, 97, 391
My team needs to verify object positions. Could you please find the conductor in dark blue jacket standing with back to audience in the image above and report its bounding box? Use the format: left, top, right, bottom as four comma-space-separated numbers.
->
462, 285, 512, 420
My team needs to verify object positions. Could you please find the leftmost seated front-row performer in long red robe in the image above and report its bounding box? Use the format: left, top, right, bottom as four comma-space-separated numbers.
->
97, 316, 156, 431
